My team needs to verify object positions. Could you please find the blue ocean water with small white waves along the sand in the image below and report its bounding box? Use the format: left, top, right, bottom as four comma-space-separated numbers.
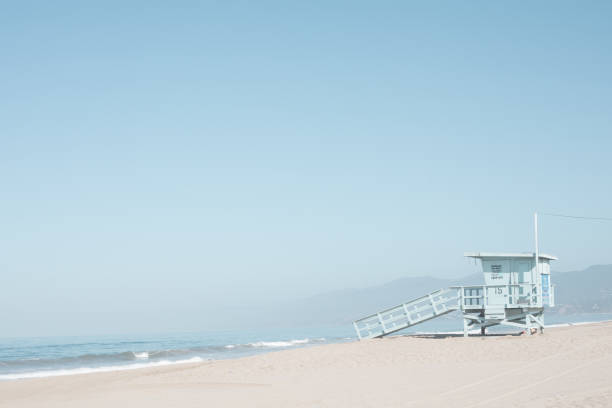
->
0, 313, 612, 380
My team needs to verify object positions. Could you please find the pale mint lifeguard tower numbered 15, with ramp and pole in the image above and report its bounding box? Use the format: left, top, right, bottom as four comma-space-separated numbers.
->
353, 215, 557, 339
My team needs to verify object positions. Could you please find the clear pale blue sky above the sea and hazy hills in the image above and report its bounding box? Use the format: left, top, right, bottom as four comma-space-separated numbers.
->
0, 1, 612, 335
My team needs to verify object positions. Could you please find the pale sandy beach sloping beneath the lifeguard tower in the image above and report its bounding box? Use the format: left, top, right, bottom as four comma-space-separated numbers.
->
0, 323, 612, 408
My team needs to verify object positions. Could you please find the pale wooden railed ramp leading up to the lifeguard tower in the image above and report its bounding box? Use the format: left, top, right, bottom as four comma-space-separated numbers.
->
353, 288, 461, 340
